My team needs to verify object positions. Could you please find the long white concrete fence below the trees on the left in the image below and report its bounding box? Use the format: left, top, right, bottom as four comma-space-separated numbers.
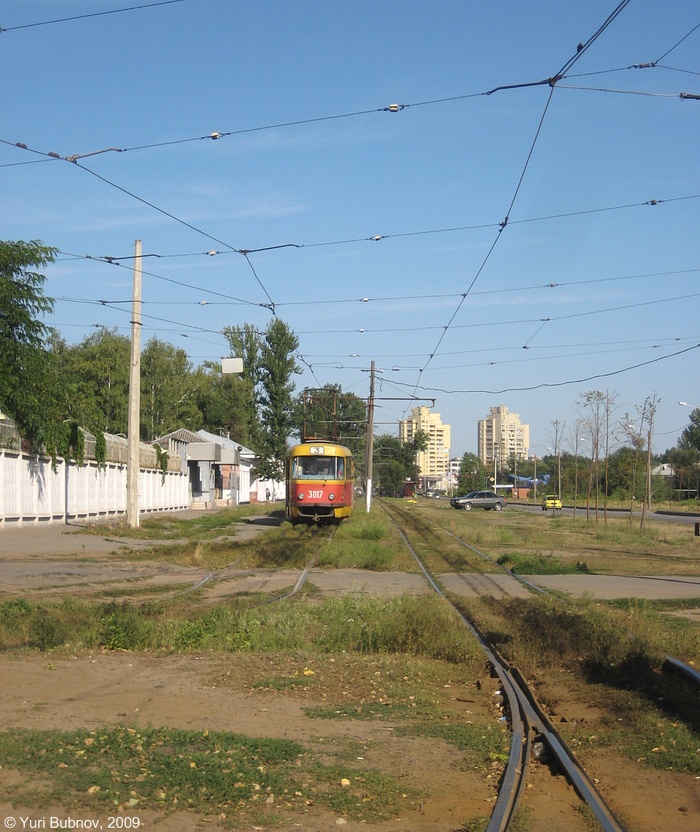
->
0, 448, 190, 529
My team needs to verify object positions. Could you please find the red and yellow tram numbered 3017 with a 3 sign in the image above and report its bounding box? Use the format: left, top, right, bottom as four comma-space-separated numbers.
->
286, 440, 355, 523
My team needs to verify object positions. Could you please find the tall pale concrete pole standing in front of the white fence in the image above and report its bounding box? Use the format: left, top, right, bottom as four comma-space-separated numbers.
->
126, 240, 141, 529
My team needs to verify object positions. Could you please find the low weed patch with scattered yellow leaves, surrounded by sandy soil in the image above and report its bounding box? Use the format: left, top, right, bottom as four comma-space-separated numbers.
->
0, 726, 405, 820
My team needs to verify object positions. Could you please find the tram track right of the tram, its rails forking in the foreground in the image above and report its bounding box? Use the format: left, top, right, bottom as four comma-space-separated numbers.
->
380, 501, 624, 832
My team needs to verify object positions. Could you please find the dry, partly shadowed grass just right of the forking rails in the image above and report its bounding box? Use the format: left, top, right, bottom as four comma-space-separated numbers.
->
456, 597, 700, 760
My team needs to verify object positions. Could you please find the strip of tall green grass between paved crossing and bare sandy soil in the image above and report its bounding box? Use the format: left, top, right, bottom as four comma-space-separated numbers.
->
0, 596, 480, 663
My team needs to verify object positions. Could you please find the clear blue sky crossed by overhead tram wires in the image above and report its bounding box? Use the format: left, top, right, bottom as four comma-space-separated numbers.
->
0, 0, 700, 456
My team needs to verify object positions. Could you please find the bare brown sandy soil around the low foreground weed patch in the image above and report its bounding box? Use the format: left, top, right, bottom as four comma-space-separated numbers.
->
0, 653, 506, 832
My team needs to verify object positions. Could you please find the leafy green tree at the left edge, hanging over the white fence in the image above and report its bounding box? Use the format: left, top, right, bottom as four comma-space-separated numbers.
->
0, 241, 60, 450
